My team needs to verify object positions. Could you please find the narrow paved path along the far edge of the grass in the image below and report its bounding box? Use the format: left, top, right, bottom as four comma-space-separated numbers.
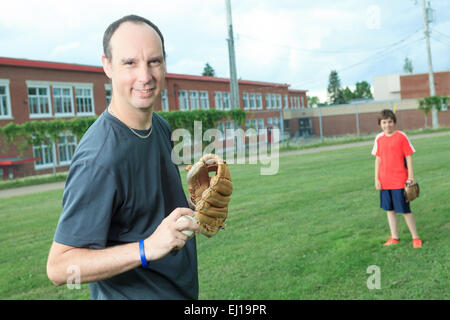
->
0, 131, 450, 199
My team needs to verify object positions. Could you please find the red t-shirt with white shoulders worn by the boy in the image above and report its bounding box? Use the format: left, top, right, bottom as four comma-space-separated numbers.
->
372, 130, 416, 190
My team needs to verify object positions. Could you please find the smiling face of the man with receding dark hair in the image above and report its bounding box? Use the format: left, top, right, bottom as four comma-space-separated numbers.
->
102, 22, 165, 109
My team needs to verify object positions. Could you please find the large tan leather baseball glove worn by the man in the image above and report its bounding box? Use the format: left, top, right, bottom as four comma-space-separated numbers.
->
186, 154, 233, 238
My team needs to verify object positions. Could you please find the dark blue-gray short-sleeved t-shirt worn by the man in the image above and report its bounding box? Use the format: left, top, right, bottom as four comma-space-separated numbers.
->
54, 110, 198, 299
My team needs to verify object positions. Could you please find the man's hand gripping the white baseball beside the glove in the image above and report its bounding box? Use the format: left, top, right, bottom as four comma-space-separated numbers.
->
144, 208, 200, 261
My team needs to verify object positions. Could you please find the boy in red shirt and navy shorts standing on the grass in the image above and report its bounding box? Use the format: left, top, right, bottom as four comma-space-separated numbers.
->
372, 109, 422, 248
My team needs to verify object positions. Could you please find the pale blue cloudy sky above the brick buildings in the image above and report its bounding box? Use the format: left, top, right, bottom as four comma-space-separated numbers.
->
0, 0, 450, 100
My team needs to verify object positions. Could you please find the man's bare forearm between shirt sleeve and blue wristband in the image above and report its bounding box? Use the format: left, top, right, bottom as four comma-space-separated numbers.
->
47, 242, 141, 285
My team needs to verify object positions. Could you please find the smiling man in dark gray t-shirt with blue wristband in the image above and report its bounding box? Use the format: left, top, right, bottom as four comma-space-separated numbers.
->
47, 16, 199, 299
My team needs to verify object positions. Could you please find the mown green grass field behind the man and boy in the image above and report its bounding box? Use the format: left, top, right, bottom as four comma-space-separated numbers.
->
0, 136, 450, 300
